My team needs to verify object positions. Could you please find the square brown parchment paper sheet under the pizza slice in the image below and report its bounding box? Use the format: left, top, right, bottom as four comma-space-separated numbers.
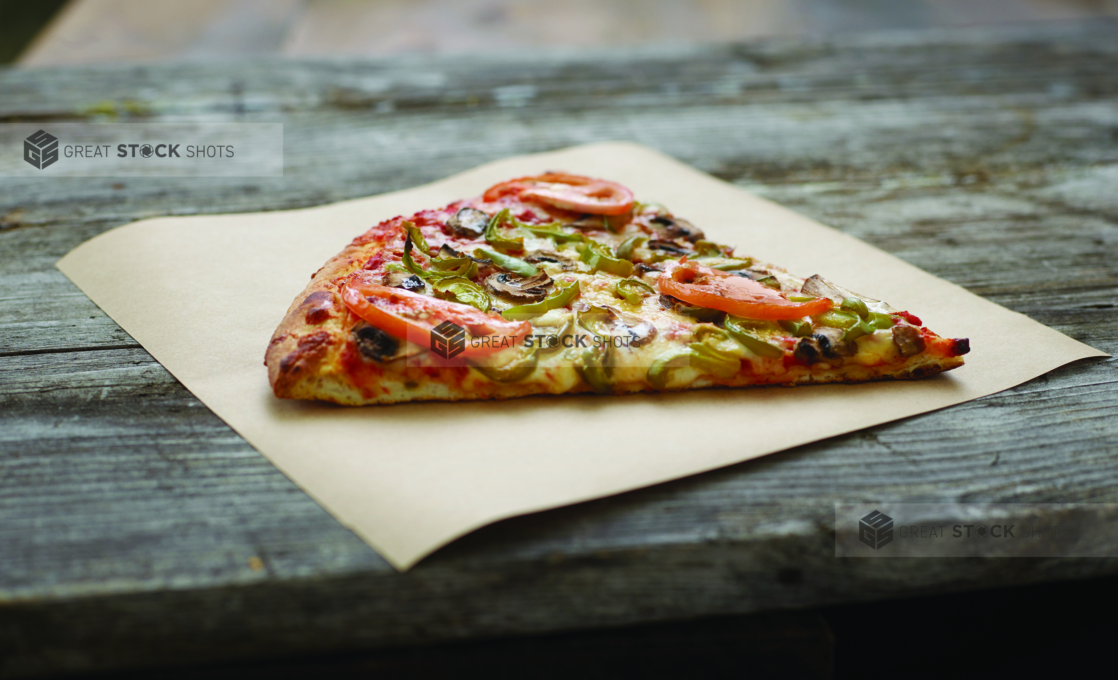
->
58, 143, 1106, 569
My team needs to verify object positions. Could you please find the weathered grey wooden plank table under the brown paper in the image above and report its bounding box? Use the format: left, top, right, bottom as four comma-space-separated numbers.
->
0, 22, 1118, 673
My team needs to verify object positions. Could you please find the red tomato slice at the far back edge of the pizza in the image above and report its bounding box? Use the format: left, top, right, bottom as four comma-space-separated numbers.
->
483, 172, 634, 215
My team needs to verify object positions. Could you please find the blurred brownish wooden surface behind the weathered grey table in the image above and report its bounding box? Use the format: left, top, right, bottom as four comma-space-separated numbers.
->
20, 0, 1118, 66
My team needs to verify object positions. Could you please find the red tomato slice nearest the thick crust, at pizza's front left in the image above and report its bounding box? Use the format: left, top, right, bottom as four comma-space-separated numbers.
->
342, 272, 532, 357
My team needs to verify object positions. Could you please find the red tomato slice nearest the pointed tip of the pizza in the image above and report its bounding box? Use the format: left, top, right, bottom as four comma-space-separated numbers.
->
657, 257, 834, 321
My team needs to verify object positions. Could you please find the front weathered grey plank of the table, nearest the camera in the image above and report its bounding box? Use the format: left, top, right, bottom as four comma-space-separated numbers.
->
0, 350, 1118, 675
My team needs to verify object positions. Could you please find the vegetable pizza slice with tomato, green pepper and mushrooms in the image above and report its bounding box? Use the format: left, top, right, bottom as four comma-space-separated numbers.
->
265, 172, 969, 405
